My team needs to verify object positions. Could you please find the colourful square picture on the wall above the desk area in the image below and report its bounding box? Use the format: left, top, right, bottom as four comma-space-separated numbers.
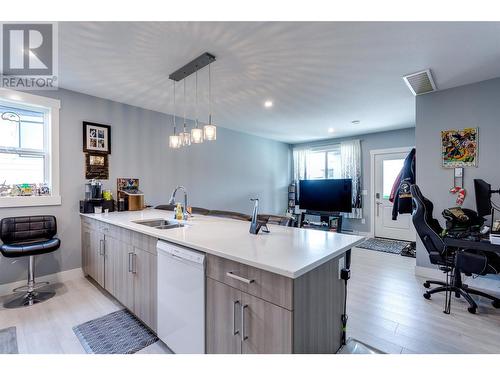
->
441, 128, 478, 168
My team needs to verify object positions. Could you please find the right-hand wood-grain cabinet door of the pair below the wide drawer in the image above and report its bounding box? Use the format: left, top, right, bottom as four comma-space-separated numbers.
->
241, 293, 292, 354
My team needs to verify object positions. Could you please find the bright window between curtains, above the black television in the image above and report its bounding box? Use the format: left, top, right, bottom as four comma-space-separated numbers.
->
307, 146, 341, 180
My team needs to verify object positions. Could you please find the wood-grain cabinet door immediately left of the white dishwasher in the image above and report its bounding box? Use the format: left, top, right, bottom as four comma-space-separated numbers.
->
132, 247, 157, 332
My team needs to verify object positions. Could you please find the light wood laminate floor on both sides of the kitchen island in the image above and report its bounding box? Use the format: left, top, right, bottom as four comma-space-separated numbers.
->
0, 249, 500, 353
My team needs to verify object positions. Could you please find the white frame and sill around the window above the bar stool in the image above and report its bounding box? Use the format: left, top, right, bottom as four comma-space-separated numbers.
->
0, 88, 61, 208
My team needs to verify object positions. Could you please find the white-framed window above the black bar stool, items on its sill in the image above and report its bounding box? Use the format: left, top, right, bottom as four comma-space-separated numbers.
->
0, 89, 61, 207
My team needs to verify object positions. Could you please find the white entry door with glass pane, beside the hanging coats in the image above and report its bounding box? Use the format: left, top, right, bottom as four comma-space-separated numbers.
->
372, 151, 416, 241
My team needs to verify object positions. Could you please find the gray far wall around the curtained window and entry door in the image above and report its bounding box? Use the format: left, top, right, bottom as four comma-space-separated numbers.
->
292, 128, 415, 232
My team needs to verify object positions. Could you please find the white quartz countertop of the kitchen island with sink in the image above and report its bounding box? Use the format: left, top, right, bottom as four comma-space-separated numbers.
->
81, 209, 364, 278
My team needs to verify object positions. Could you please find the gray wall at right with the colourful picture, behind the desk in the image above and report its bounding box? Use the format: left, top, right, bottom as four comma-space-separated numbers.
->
416, 79, 500, 267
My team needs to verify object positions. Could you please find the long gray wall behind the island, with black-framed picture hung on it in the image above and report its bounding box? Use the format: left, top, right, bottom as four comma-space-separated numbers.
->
0, 90, 291, 284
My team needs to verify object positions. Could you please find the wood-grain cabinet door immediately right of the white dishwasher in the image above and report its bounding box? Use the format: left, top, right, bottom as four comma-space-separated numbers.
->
206, 277, 242, 354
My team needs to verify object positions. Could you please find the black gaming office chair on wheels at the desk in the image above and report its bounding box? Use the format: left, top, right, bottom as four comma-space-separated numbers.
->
410, 185, 500, 314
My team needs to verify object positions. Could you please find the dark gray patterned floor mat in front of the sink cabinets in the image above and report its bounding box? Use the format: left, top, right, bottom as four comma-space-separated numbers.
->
73, 310, 158, 354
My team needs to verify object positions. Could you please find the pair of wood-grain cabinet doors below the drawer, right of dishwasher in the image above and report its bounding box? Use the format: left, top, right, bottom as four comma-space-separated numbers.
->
206, 278, 292, 354
